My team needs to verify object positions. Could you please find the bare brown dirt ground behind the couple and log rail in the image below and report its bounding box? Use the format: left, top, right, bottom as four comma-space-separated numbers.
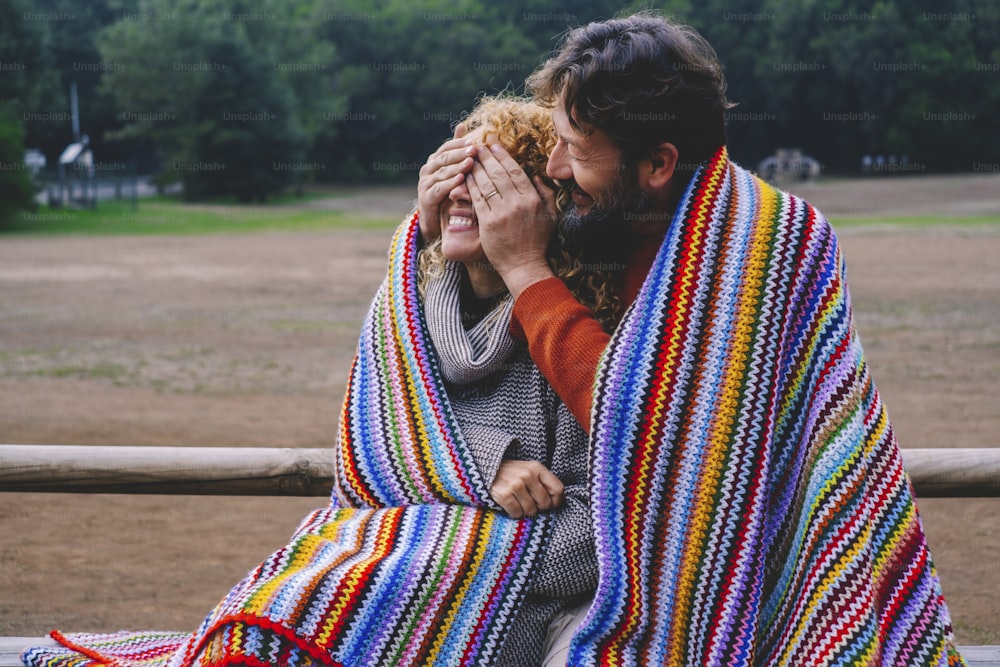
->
0, 176, 1000, 644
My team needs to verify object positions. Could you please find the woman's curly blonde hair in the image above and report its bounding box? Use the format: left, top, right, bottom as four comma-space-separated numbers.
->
419, 96, 622, 333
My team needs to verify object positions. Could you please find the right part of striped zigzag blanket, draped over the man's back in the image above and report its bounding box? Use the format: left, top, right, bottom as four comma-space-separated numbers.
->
570, 149, 962, 667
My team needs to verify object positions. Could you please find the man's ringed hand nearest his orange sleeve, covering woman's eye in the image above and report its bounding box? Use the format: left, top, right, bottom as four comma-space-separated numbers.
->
466, 145, 558, 299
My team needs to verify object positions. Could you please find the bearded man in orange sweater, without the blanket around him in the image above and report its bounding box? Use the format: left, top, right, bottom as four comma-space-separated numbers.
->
469, 15, 730, 428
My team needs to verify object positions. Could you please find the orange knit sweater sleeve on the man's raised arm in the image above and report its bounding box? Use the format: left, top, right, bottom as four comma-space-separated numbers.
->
511, 278, 611, 433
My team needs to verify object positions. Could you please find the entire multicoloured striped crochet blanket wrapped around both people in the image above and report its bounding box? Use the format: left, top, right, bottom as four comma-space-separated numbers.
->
21, 150, 962, 667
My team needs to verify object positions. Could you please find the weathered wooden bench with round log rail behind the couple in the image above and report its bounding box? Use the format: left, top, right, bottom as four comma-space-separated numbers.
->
0, 445, 1000, 667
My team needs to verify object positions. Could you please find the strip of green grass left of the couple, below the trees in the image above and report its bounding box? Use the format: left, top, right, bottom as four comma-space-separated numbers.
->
2, 197, 399, 235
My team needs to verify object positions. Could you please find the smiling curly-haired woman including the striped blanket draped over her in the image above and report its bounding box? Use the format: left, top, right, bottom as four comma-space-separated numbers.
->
25, 99, 603, 665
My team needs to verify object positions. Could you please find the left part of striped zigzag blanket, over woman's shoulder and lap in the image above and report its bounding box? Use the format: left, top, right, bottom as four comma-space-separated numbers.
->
22, 218, 550, 667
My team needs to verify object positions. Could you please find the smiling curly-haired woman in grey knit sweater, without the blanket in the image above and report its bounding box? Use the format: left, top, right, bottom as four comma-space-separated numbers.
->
410, 98, 604, 664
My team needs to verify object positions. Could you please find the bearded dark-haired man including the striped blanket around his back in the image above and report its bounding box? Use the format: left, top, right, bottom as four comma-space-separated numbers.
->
434, 14, 962, 665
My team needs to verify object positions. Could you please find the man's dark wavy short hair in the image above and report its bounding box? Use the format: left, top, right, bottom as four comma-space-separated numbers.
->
526, 12, 732, 171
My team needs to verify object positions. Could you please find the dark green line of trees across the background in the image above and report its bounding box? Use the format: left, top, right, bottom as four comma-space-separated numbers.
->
0, 0, 1000, 210
